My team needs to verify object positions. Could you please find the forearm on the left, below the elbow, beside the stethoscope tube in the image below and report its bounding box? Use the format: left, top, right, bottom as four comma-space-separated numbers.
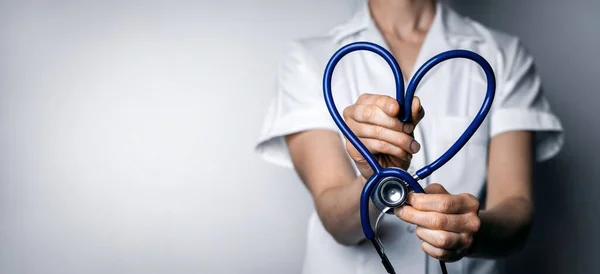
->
315, 176, 378, 245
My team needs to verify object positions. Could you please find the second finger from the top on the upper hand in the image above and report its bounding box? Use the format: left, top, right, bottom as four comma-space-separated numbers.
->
344, 104, 403, 132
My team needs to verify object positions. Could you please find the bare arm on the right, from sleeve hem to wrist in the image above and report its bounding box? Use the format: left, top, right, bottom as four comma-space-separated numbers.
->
471, 131, 534, 258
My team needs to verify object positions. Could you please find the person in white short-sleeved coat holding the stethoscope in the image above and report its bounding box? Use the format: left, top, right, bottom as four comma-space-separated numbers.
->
257, 0, 563, 273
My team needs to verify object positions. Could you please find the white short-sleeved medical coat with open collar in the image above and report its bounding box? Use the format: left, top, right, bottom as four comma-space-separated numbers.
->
256, 1, 563, 274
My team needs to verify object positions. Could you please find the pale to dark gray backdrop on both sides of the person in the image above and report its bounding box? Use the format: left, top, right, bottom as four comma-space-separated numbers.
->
0, 0, 600, 274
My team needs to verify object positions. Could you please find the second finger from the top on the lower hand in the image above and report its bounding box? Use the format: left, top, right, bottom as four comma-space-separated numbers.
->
395, 205, 481, 233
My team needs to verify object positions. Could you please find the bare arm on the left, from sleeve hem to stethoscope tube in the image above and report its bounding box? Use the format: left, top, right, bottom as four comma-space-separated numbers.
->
286, 130, 375, 245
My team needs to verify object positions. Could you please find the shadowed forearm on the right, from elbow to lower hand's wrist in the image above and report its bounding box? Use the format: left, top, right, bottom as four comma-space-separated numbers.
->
470, 197, 533, 258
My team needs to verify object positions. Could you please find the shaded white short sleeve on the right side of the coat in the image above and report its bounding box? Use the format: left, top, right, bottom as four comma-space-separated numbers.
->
490, 39, 564, 161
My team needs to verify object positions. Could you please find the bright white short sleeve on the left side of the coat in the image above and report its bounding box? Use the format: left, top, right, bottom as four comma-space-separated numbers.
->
255, 42, 336, 168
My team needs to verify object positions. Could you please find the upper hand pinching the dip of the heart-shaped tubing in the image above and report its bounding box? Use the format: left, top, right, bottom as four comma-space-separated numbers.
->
344, 94, 425, 179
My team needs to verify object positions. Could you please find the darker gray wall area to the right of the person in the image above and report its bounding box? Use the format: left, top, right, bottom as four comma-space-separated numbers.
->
451, 0, 600, 273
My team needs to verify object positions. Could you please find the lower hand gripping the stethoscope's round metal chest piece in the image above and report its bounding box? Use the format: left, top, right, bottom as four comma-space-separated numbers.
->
395, 184, 481, 262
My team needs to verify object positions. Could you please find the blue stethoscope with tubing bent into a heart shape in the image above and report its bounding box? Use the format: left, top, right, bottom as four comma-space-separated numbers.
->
323, 42, 496, 274
